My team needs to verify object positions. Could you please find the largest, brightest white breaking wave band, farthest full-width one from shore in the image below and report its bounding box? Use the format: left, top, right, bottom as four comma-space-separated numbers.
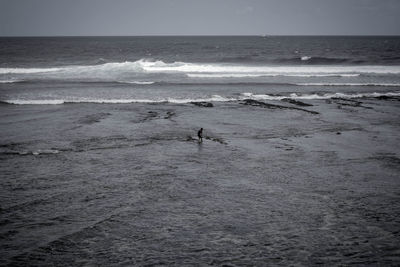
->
0, 59, 400, 77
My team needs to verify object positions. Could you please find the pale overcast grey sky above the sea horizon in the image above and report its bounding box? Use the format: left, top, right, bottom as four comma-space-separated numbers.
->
0, 0, 400, 36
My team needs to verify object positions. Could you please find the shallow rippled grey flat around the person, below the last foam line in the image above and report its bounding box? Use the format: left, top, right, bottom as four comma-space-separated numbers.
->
0, 98, 400, 266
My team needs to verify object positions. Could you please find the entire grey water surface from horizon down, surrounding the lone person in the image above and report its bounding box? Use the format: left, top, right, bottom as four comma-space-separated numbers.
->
0, 36, 400, 266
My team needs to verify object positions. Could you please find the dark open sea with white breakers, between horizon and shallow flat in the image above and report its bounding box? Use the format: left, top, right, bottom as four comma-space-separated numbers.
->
0, 36, 400, 104
